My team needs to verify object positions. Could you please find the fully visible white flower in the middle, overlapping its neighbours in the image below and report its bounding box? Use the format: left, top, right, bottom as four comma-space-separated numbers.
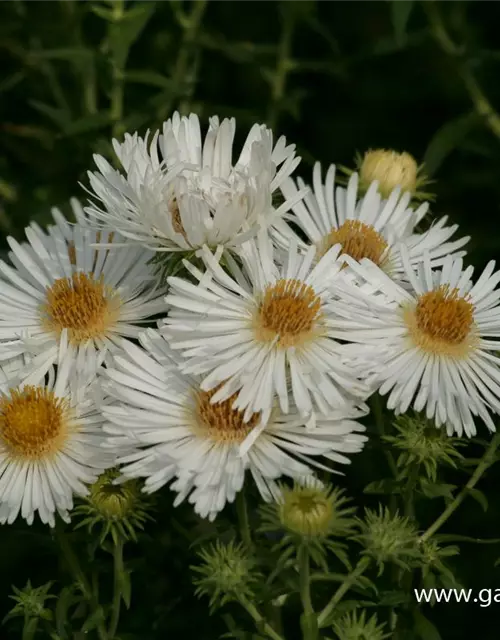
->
161, 232, 367, 422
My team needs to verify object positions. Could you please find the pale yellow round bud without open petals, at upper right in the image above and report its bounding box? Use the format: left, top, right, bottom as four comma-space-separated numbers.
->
359, 149, 418, 198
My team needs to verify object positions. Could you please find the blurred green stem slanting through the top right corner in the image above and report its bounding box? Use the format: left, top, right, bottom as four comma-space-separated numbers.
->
423, 0, 500, 138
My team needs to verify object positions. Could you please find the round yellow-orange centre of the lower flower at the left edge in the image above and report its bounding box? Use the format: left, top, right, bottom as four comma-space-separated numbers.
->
0, 386, 69, 460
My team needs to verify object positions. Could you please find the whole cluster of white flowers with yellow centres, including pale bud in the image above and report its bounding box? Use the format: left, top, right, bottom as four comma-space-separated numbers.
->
0, 114, 500, 526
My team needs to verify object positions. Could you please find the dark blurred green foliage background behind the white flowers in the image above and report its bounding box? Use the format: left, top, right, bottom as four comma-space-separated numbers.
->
0, 0, 500, 640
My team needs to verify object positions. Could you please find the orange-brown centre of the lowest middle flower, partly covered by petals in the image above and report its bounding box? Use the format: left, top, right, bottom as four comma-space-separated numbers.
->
195, 389, 260, 444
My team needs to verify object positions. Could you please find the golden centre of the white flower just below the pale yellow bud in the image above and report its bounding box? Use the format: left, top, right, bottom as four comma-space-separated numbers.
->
319, 220, 388, 266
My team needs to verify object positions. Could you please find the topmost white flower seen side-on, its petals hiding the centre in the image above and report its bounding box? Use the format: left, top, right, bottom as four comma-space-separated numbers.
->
86, 113, 303, 251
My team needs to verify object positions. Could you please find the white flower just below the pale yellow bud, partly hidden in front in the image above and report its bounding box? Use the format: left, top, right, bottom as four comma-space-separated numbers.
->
273, 163, 469, 282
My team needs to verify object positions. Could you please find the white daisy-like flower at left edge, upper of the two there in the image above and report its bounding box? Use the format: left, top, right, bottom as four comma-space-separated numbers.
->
0, 202, 167, 378
